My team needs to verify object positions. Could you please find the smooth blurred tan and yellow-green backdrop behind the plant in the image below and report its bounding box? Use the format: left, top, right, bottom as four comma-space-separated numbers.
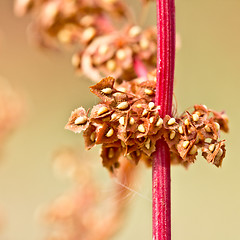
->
0, 0, 240, 240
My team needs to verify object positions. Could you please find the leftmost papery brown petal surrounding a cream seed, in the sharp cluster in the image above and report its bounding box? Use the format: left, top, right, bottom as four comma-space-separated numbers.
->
65, 107, 89, 133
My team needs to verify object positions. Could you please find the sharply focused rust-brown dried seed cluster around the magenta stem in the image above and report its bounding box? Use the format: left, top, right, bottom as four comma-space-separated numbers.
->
66, 75, 228, 172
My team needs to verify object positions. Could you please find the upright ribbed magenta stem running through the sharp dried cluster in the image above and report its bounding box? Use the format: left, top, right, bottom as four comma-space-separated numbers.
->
152, 0, 175, 240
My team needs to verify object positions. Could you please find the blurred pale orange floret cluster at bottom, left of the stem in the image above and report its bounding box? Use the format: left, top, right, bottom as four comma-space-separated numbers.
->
42, 149, 134, 240
